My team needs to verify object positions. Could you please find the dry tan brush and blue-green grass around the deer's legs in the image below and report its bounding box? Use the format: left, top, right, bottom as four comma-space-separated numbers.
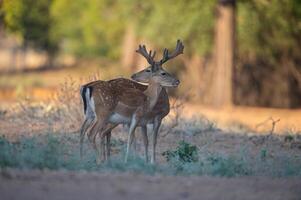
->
0, 75, 301, 177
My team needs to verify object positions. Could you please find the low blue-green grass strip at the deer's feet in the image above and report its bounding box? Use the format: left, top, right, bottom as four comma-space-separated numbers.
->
0, 133, 301, 177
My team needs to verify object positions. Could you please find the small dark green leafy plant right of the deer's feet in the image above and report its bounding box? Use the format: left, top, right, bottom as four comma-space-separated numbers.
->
162, 140, 198, 163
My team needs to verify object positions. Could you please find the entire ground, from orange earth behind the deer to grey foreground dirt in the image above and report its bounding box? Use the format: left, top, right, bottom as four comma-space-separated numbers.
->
0, 65, 301, 200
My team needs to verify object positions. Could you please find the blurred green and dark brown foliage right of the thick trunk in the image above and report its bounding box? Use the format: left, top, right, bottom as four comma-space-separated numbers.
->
235, 0, 301, 107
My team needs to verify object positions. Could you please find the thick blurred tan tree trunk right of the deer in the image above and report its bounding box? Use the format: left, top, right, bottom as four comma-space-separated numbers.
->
213, 0, 235, 106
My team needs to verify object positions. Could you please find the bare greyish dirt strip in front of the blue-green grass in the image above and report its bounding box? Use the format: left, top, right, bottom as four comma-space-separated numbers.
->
0, 170, 301, 200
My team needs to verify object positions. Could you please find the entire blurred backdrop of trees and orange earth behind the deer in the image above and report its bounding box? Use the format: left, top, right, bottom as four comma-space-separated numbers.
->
0, 0, 301, 130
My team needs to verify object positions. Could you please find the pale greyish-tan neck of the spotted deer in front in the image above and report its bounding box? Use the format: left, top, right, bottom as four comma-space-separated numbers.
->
144, 81, 162, 111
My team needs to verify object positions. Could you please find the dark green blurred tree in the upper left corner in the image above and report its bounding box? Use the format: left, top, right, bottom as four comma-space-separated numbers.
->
3, 0, 58, 66
